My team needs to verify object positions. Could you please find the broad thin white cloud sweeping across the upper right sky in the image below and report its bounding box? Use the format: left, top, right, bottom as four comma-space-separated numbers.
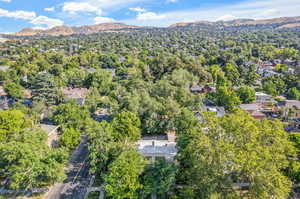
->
122, 0, 300, 26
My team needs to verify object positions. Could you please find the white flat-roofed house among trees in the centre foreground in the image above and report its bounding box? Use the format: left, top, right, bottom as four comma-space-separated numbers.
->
136, 132, 177, 163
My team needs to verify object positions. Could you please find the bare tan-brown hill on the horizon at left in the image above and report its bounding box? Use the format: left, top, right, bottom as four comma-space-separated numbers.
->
14, 23, 138, 36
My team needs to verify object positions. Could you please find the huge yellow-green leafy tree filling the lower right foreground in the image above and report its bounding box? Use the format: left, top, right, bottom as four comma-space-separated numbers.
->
177, 111, 295, 199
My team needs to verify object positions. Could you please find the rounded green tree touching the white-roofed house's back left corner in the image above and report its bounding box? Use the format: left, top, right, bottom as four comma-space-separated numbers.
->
111, 112, 141, 141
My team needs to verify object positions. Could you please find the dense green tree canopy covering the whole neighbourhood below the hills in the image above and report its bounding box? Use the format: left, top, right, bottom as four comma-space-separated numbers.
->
0, 23, 300, 199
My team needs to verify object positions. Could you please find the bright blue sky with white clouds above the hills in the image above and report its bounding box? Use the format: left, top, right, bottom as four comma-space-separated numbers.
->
0, 0, 300, 33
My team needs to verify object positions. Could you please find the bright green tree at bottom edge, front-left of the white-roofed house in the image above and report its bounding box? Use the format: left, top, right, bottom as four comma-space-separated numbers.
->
105, 150, 146, 199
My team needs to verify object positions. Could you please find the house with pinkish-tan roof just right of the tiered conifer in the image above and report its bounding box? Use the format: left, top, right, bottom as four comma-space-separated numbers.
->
61, 88, 88, 105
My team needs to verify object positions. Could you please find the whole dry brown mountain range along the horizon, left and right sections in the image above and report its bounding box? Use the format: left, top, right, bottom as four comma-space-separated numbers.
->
13, 17, 300, 36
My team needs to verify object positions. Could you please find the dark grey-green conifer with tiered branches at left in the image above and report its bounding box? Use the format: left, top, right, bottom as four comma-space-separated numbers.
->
31, 73, 62, 106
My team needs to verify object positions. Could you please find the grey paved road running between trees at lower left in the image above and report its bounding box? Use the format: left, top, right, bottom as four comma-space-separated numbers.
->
44, 137, 90, 199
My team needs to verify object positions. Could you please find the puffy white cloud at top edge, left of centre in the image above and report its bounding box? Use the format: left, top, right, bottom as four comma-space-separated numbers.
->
63, 2, 102, 15
